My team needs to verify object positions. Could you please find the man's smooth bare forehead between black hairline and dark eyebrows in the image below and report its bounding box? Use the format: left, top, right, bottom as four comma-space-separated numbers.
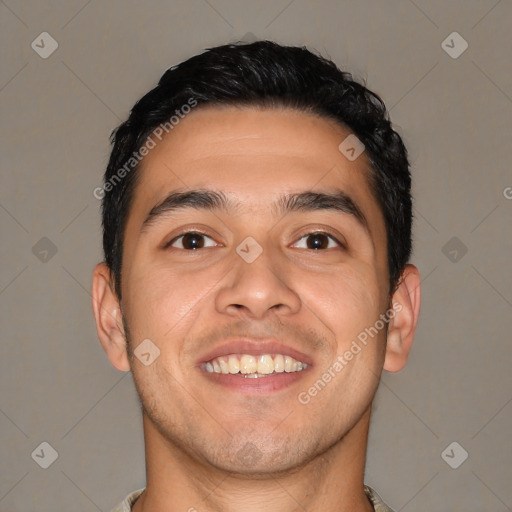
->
132, 106, 376, 213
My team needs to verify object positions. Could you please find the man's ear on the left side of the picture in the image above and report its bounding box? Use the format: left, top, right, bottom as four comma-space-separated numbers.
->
92, 263, 130, 372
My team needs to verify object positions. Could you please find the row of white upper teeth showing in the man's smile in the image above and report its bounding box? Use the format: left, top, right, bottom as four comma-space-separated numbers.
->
204, 354, 308, 375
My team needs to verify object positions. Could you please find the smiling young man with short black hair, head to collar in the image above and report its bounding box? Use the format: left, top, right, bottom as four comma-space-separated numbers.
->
92, 41, 420, 512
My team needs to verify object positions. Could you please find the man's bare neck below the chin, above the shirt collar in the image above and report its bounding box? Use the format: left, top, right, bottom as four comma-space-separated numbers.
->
133, 406, 373, 512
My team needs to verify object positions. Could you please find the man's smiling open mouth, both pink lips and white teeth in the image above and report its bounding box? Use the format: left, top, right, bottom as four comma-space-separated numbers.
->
198, 341, 313, 395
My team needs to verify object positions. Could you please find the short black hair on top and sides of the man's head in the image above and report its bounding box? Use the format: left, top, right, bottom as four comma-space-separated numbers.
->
101, 41, 412, 300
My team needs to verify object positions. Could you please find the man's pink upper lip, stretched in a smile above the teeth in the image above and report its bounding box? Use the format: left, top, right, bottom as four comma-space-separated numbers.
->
196, 338, 313, 366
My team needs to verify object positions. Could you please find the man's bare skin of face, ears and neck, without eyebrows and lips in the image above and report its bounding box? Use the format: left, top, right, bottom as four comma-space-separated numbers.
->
92, 107, 420, 512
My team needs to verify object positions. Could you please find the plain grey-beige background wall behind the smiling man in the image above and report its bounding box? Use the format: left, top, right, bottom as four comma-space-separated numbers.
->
0, 0, 512, 512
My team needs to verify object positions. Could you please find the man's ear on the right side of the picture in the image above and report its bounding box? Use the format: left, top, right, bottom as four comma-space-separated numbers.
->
384, 265, 421, 372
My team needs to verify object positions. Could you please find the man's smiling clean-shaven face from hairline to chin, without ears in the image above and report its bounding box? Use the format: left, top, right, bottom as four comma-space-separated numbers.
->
117, 107, 389, 473
